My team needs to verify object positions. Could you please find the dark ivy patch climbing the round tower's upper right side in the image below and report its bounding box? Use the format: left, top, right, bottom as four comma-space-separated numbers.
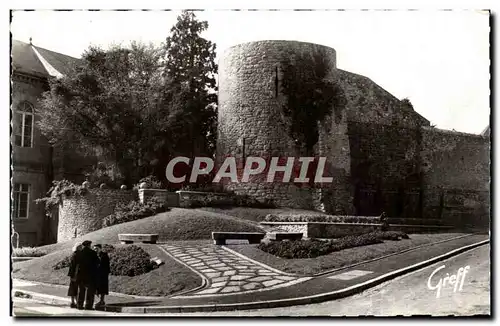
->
281, 51, 347, 155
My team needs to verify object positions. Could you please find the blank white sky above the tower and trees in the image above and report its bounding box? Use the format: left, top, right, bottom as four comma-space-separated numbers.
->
11, 10, 490, 134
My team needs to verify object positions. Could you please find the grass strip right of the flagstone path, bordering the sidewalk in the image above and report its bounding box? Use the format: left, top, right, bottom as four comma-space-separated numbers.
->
228, 233, 463, 275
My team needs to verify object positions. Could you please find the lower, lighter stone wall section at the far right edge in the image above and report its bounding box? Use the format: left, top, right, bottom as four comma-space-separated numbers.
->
421, 128, 491, 227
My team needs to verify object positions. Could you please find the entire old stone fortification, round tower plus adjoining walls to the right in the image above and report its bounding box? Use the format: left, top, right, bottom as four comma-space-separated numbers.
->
217, 41, 490, 225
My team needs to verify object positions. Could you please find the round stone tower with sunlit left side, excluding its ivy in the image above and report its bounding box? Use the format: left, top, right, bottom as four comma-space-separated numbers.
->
217, 41, 349, 208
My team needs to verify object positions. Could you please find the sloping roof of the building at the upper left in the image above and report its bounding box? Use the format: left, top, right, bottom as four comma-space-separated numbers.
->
11, 40, 80, 77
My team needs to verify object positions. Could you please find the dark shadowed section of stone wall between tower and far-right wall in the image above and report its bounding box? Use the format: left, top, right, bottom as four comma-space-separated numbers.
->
349, 121, 422, 218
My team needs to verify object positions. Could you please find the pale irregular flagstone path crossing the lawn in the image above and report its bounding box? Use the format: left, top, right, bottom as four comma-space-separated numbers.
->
163, 245, 310, 296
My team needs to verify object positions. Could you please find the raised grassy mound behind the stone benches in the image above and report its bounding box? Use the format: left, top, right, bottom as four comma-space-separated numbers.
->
38, 208, 263, 253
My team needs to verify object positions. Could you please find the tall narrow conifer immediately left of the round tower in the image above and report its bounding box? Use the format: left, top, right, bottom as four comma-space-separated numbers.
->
165, 11, 217, 157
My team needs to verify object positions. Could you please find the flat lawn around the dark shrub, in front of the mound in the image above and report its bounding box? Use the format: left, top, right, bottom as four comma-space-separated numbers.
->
12, 244, 201, 296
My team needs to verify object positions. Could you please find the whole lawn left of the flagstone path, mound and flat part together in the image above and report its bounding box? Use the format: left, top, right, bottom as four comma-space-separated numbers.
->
12, 208, 263, 296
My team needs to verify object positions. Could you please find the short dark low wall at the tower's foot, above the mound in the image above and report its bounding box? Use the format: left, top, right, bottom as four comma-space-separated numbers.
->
177, 190, 236, 208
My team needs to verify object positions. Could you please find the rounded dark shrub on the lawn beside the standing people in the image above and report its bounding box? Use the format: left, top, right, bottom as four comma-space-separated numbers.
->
109, 245, 157, 276
